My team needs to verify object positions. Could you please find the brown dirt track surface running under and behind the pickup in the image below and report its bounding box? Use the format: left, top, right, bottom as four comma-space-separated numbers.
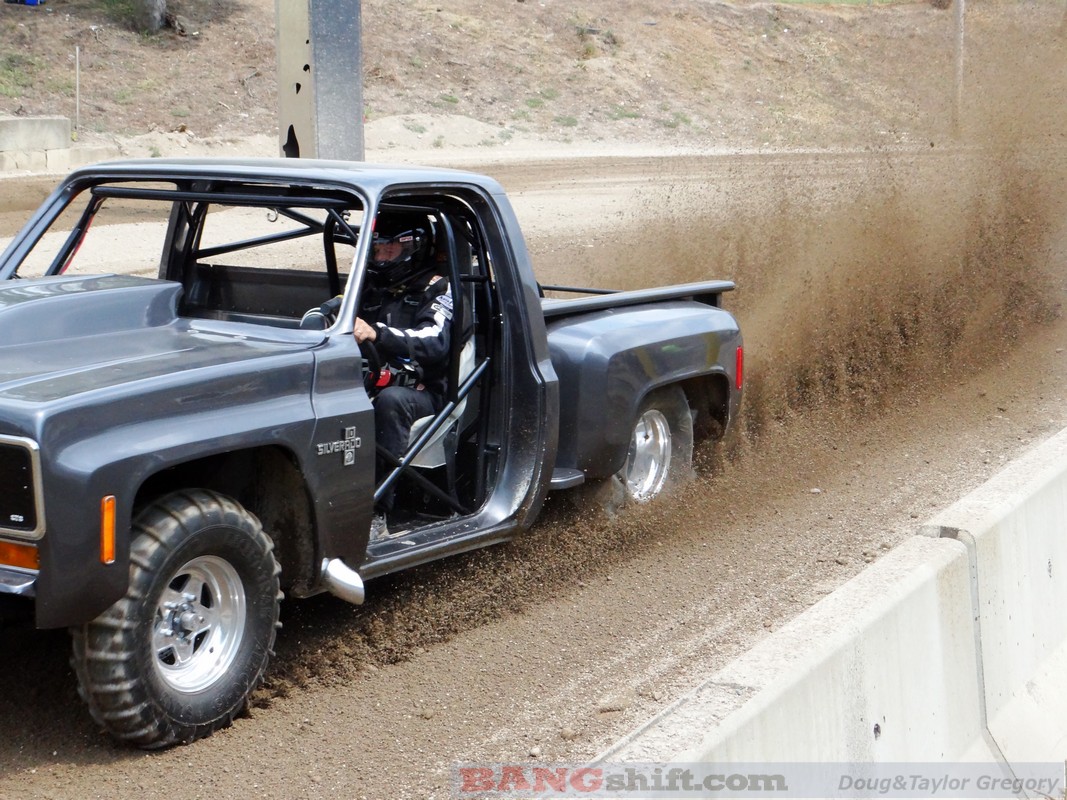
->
0, 140, 1067, 800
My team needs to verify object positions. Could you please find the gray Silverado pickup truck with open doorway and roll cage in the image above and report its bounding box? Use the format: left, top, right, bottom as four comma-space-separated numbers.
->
0, 159, 742, 748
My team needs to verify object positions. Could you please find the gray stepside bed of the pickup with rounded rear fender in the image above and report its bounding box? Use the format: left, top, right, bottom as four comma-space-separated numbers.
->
541, 281, 740, 478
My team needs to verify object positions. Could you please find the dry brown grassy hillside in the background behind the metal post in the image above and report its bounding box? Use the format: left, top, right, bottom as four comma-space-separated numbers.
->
0, 0, 1063, 154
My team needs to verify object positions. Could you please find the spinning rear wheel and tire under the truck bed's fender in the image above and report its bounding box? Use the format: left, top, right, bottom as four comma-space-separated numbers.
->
593, 386, 694, 516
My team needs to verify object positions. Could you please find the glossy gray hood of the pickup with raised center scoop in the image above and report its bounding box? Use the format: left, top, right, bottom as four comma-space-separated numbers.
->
0, 275, 314, 403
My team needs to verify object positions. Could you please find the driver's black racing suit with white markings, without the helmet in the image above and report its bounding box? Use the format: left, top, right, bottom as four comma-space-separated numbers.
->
360, 273, 452, 513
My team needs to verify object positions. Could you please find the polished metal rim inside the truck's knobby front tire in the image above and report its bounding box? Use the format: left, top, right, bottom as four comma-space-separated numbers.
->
152, 556, 248, 692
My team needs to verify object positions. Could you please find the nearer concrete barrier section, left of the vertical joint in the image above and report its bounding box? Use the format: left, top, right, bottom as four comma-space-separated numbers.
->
599, 537, 993, 763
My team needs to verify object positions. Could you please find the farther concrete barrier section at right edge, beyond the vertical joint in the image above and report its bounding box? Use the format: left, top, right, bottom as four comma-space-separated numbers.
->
926, 431, 1067, 762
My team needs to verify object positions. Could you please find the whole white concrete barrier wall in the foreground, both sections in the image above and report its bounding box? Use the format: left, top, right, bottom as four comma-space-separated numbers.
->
598, 431, 1067, 763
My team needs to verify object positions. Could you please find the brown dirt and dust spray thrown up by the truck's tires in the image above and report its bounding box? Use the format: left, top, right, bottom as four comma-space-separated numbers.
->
257, 12, 1067, 705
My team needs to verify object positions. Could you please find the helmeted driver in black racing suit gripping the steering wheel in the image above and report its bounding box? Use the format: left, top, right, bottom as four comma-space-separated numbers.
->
352, 226, 452, 541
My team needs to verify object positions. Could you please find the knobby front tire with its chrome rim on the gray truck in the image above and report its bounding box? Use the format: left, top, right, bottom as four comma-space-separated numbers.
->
71, 490, 282, 749
